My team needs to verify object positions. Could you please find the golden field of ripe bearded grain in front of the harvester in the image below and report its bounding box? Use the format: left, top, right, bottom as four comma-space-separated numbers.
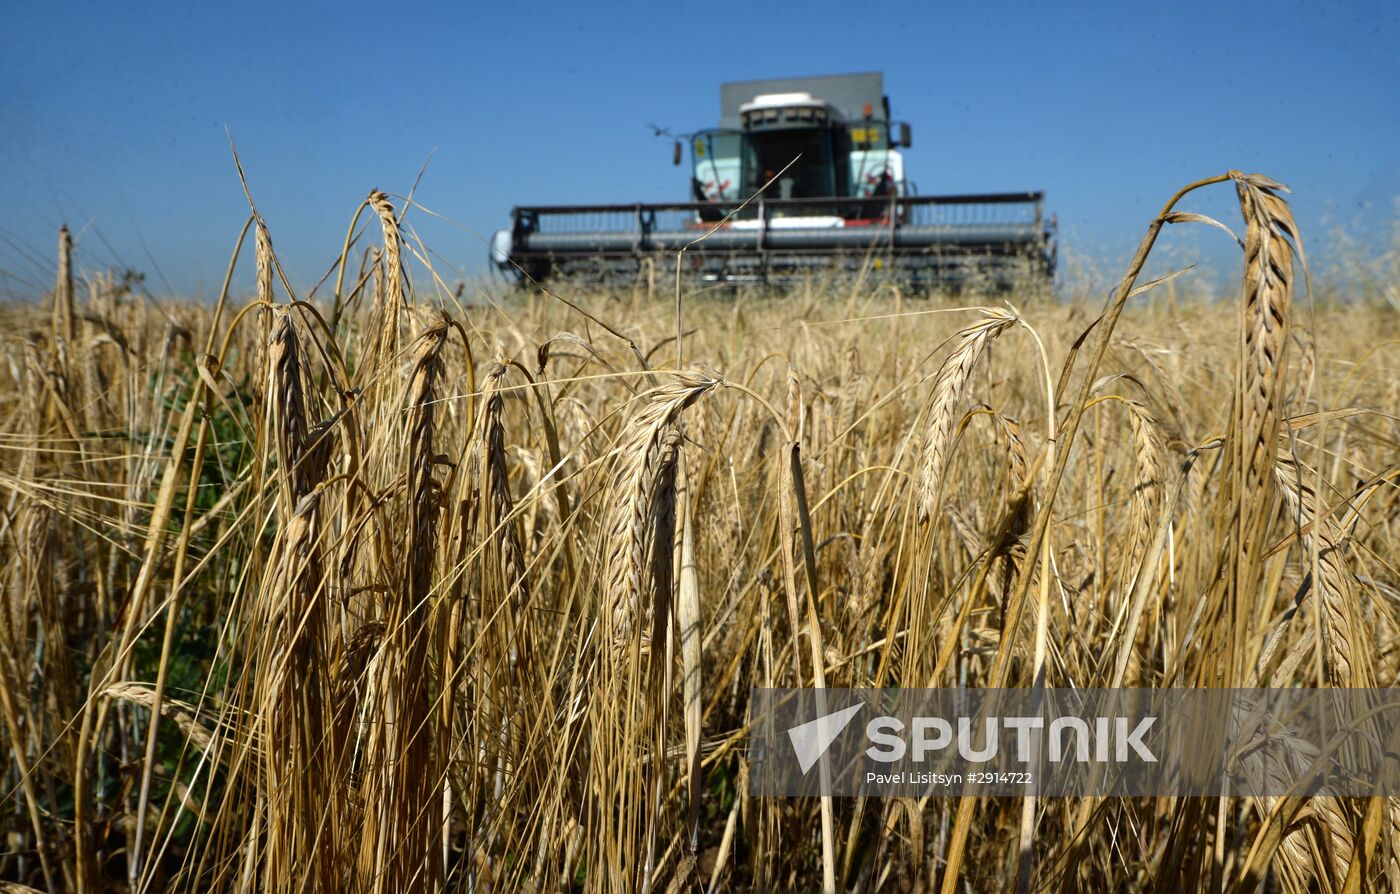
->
0, 172, 1400, 894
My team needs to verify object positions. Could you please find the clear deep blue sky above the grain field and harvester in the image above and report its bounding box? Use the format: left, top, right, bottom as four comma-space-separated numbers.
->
0, 0, 1400, 295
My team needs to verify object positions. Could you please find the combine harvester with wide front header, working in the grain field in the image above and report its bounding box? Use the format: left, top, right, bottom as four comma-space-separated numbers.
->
491, 73, 1056, 288
